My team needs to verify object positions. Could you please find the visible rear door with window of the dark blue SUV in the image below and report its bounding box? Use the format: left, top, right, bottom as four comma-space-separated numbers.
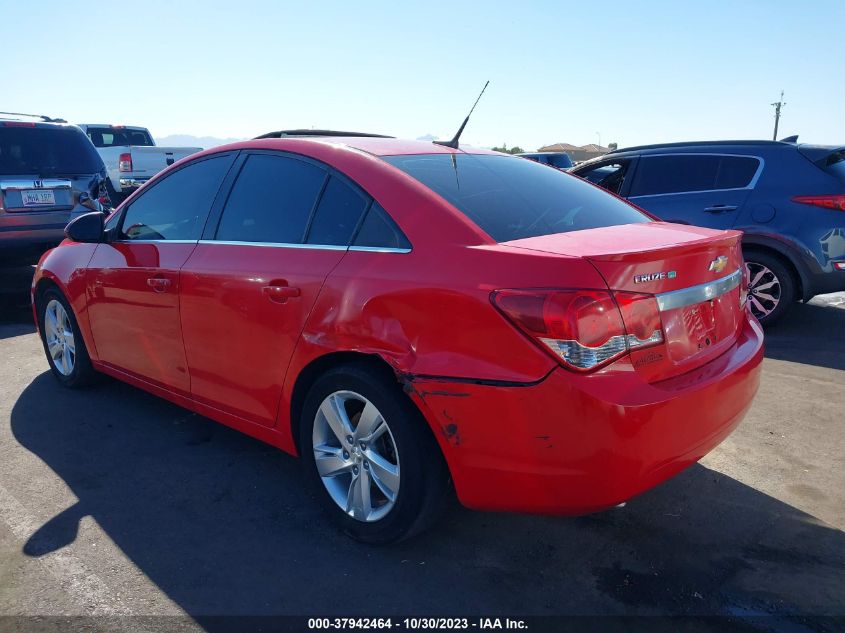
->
627, 154, 763, 229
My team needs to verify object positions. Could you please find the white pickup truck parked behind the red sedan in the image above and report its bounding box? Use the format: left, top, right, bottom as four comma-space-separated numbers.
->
79, 123, 202, 203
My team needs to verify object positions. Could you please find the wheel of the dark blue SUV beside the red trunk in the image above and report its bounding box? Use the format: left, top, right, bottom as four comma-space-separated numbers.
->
745, 251, 797, 326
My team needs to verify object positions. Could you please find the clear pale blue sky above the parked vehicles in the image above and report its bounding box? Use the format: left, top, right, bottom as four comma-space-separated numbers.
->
0, 0, 845, 149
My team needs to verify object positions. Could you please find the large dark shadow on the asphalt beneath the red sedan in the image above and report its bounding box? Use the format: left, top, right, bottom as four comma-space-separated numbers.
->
11, 373, 845, 631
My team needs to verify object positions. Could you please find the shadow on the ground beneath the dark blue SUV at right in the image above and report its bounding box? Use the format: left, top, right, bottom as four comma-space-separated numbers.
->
766, 303, 845, 369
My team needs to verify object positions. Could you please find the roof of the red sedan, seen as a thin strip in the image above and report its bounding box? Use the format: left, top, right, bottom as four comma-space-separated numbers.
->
205, 136, 501, 156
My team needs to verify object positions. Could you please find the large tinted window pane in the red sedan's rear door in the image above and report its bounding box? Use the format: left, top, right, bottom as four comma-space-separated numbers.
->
217, 154, 326, 244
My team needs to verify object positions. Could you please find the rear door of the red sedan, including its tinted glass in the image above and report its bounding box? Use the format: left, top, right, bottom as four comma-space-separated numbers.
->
181, 152, 369, 426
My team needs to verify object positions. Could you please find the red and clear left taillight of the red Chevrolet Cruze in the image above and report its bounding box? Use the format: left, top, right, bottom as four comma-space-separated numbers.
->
492, 290, 663, 371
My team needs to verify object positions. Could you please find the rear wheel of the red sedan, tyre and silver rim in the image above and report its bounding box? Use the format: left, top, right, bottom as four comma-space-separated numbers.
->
300, 364, 450, 544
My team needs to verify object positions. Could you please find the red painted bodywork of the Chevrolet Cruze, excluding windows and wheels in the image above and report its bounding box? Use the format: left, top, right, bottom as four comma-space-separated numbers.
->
29, 139, 762, 513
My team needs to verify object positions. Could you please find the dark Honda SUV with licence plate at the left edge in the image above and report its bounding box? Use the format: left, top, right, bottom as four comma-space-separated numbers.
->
0, 113, 108, 264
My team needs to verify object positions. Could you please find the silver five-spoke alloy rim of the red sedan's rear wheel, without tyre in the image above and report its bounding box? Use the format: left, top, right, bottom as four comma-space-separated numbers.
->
312, 391, 401, 523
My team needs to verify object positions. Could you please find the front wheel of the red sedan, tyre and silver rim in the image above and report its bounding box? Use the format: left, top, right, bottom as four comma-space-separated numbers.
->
38, 288, 94, 388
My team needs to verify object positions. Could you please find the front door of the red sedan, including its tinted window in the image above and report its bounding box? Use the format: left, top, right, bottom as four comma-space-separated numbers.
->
87, 153, 235, 395
